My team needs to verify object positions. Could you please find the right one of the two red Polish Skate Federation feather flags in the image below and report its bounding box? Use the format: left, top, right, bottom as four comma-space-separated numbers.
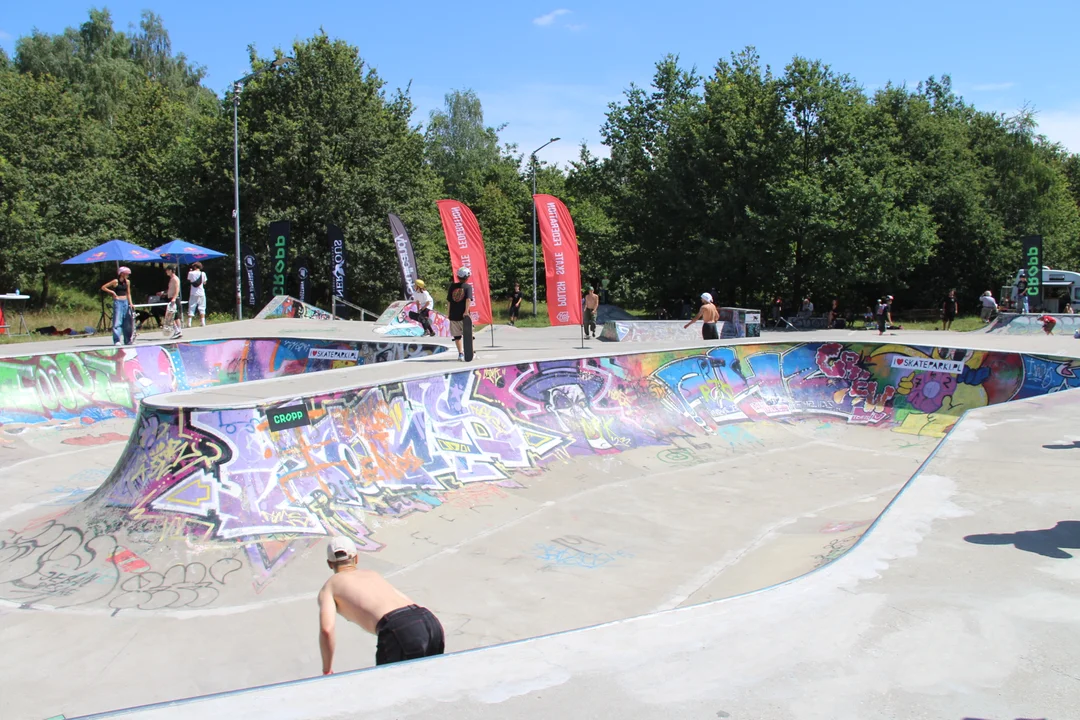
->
532, 195, 581, 325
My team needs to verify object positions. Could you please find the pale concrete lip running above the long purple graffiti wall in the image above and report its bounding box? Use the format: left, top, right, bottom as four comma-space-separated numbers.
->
141, 328, 1080, 417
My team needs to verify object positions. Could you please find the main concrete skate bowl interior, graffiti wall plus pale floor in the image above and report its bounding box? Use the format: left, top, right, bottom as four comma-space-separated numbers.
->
6, 341, 1080, 718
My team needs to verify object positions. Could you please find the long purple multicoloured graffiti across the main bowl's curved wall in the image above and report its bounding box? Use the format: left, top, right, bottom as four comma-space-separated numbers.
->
0, 342, 1080, 608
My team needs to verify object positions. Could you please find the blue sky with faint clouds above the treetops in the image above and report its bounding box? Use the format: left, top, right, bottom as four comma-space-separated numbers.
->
0, 0, 1080, 162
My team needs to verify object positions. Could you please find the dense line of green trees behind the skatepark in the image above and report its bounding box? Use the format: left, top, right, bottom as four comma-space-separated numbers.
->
0, 11, 1080, 312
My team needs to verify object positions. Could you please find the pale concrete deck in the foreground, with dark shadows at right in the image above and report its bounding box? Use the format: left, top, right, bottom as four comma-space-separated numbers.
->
82, 391, 1080, 720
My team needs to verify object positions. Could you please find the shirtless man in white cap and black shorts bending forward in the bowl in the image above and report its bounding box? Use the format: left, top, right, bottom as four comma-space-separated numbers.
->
319, 536, 444, 675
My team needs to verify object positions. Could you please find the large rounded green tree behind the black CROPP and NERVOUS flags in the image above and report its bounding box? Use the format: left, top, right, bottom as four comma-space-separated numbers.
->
225, 32, 437, 310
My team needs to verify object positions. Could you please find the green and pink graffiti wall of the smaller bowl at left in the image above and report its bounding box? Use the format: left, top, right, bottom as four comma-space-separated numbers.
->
0, 338, 445, 425
